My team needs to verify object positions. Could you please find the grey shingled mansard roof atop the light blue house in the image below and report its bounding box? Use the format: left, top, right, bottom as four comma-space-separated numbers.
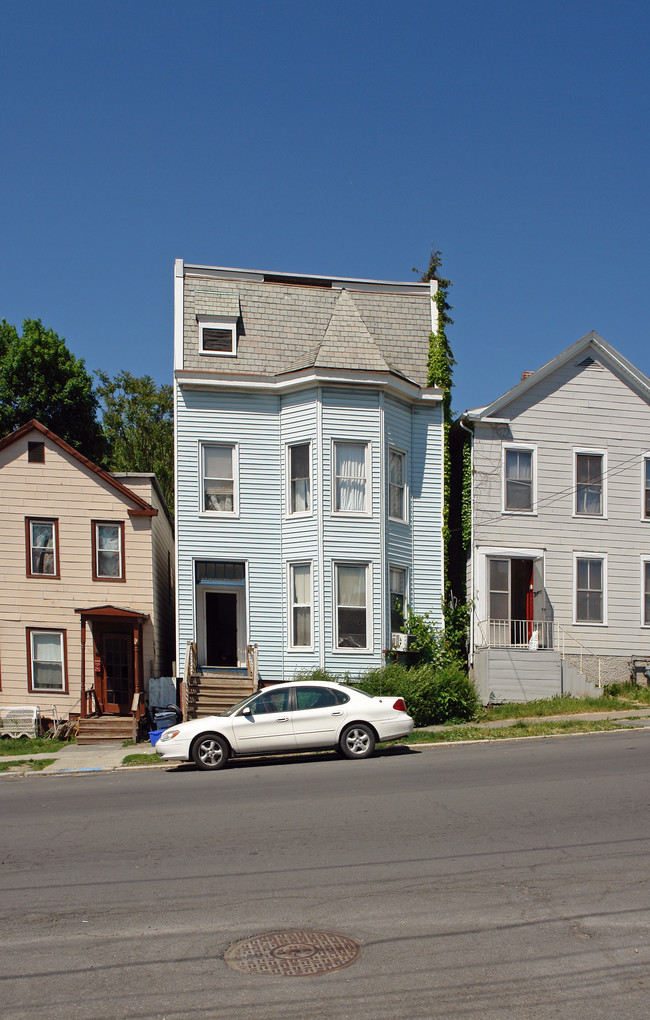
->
176, 259, 437, 395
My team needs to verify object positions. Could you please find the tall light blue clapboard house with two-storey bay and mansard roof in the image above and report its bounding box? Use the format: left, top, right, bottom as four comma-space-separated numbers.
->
174, 260, 443, 701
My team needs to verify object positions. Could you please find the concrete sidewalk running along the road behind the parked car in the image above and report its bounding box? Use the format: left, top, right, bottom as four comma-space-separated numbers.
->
0, 708, 650, 778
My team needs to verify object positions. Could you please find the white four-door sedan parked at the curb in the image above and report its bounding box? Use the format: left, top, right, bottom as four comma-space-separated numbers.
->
155, 681, 413, 769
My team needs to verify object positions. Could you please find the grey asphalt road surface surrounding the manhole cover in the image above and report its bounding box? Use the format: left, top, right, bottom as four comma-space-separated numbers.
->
0, 730, 650, 1020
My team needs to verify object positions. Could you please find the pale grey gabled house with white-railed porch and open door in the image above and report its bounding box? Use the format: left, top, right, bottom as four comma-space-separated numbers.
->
461, 333, 650, 703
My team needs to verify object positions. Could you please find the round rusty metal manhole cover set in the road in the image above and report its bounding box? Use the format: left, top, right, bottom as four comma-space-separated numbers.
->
223, 931, 361, 977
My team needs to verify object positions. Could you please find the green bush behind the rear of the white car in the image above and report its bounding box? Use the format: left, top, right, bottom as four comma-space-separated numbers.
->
357, 662, 479, 726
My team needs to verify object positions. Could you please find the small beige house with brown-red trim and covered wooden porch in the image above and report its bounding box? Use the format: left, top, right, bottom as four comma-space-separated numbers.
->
0, 421, 173, 738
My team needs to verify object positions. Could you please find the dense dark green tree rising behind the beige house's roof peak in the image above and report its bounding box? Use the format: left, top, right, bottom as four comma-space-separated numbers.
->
0, 319, 104, 462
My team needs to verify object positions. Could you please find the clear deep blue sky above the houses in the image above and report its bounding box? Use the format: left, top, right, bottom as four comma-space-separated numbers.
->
0, 0, 650, 411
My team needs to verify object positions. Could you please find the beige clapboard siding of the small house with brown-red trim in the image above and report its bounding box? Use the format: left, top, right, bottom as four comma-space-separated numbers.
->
0, 432, 173, 715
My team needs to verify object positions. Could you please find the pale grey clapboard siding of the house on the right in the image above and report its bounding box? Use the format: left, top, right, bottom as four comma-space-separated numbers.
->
473, 338, 650, 658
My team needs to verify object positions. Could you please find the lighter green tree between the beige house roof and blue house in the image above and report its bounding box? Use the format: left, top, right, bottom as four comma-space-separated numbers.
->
95, 371, 173, 513
